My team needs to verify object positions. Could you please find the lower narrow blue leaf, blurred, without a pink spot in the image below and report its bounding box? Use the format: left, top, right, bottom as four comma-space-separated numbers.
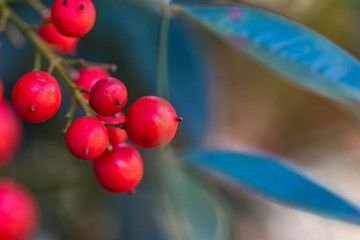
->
187, 150, 360, 224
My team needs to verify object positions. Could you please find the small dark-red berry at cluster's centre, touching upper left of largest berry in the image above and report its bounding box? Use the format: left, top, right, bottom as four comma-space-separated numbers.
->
89, 77, 127, 116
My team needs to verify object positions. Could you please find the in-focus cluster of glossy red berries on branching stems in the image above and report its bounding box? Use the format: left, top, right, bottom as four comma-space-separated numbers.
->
11, 0, 182, 193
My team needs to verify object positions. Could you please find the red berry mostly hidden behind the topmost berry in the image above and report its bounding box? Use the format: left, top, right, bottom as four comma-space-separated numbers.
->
38, 17, 79, 54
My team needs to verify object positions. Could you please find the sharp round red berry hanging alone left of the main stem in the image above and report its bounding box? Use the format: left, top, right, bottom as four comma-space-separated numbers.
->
11, 71, 61, 123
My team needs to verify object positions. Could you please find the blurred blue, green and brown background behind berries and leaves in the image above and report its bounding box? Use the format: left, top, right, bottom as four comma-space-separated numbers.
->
0, 0, 360, 240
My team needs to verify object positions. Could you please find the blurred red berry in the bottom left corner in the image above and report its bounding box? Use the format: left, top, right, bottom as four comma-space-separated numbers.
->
0, 178, 38, 240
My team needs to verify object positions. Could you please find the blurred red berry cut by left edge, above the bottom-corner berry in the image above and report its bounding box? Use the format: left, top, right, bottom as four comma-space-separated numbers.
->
0, 100, 22, 170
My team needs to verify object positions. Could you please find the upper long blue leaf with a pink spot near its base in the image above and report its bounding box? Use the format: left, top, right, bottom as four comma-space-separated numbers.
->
180, 5, 360, 104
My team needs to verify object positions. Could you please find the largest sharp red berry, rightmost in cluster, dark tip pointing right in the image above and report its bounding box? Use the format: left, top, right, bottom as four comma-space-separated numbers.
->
124, 96, 181, 148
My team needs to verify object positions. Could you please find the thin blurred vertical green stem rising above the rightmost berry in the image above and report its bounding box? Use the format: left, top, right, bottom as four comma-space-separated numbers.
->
157, 2, 171, 99
